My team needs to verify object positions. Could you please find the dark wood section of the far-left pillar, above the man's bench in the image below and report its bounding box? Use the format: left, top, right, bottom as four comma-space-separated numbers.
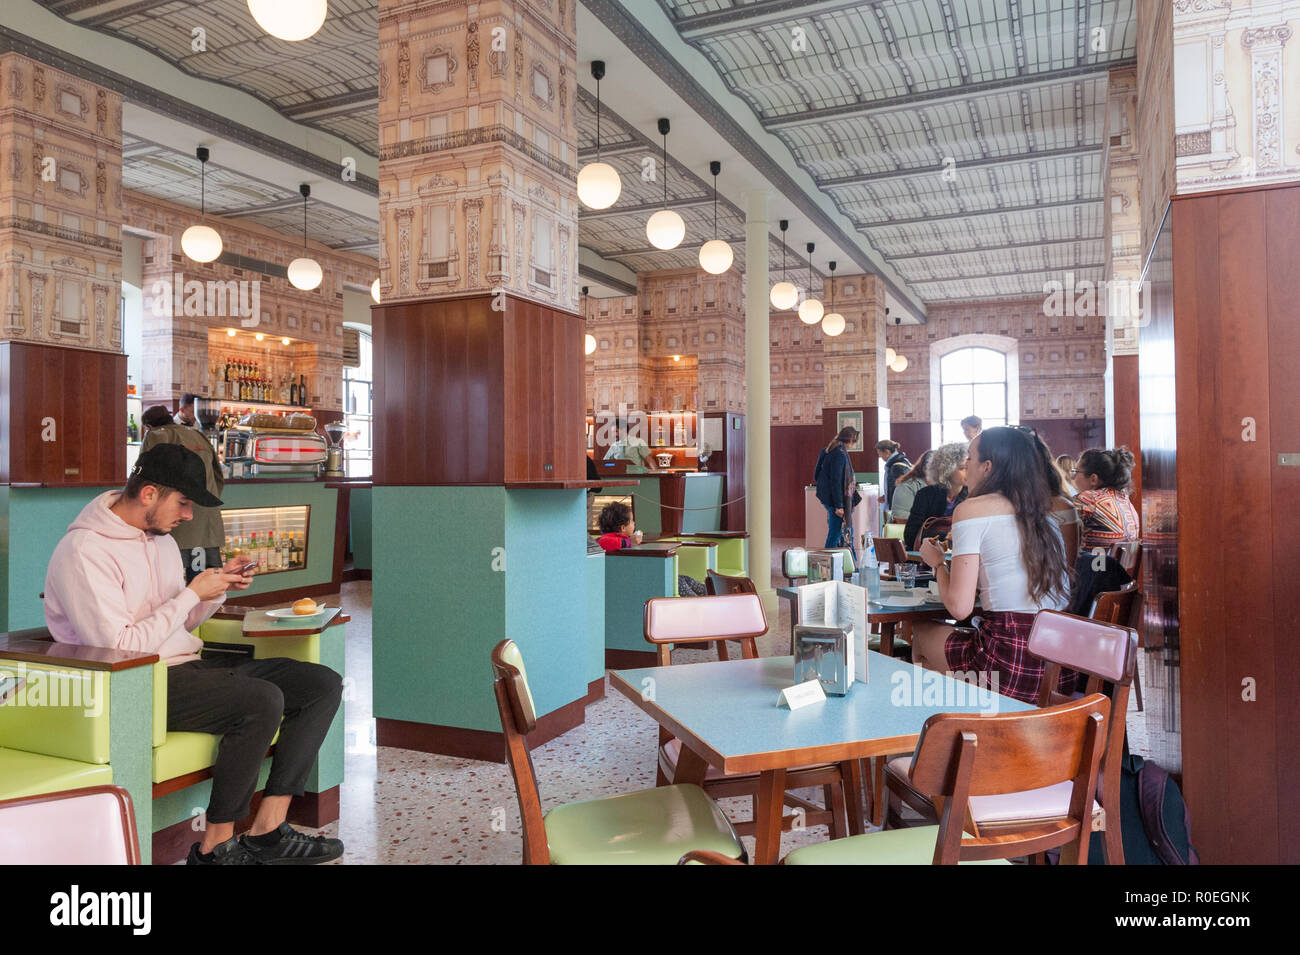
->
0, 342, 126, 487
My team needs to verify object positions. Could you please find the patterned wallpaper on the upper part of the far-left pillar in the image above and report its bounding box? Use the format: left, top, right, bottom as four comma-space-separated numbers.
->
0, 53, 122, 352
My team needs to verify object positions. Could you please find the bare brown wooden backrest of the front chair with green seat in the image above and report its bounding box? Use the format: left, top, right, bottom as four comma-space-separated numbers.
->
910, 693, 1110, 865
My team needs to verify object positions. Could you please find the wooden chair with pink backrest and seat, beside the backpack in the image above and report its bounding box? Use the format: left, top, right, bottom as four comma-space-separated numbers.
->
885, 611, 1138, 865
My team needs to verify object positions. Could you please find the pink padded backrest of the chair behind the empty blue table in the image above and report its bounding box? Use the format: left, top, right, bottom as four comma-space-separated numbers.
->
645, 592, 767, 667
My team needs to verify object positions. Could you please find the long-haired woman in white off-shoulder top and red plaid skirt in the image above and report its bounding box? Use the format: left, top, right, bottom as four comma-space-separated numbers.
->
913, 427, 1076, 703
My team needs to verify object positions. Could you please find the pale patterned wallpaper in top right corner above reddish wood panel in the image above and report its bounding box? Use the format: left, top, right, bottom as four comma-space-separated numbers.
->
1173, 0, 1300, 195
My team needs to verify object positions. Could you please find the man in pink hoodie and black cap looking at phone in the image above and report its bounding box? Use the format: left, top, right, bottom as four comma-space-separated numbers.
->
44, 444, 343, 865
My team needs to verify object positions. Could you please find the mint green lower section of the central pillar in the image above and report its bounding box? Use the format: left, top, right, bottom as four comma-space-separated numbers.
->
372, 486, 590, 732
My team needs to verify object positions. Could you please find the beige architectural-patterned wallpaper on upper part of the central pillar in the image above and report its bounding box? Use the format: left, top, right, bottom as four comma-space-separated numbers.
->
380, 0, 579, 312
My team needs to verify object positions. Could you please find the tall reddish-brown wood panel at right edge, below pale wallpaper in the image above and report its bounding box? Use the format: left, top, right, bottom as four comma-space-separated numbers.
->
1170, 186, 1300, 864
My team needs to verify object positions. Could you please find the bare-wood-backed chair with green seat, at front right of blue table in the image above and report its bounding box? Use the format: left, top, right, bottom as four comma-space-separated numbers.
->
680, 693, 1110, 865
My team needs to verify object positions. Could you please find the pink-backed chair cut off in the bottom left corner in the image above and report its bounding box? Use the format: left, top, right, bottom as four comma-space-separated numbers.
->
0, 786, 140, 865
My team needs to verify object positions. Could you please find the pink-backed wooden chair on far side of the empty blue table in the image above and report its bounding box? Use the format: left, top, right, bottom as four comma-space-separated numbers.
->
645, 595, 865, 838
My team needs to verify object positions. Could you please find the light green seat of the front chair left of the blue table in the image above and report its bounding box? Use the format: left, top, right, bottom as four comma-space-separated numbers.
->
546, 785, 744, 865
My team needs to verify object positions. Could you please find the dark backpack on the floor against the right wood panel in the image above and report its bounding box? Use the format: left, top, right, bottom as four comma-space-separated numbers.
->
1088, 754, 1201, 865
